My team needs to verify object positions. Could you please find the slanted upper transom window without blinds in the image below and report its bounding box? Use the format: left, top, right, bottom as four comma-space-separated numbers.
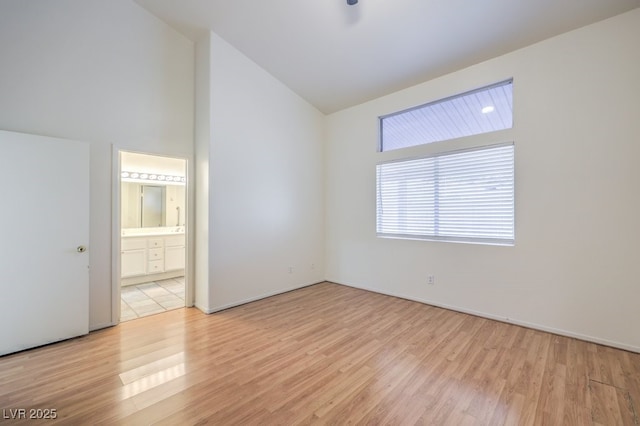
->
380, 80, 513, 151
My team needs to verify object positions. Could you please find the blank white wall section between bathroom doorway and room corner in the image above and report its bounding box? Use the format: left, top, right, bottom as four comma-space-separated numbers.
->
196, 34, 324, 312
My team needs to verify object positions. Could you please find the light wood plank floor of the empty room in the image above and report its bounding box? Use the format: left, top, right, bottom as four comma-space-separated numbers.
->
0, 283, 640, 425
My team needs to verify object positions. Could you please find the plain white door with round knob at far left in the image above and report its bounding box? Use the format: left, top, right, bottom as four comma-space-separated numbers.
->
0, 131, 89, 355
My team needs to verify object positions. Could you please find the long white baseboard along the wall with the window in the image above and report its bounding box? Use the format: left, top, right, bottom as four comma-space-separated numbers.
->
327, 279, 640, 353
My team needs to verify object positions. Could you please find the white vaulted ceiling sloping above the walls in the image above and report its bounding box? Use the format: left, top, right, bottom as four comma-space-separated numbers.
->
135, 0, 640, 113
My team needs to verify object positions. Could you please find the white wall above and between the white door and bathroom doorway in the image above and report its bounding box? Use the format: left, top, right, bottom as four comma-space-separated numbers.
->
0, 0, 194, 329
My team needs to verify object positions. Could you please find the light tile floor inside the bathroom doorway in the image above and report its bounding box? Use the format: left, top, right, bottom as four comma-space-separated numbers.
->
120, 277, 184, 321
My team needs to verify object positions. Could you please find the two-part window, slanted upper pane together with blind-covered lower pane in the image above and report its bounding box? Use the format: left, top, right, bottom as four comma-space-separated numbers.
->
376, 80, 515, 245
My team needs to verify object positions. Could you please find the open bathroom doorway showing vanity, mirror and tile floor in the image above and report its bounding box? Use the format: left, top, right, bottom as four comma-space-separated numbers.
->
118, 151, 188, 322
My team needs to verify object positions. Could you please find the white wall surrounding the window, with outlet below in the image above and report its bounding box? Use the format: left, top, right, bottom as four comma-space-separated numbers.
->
325, 9, 640, 351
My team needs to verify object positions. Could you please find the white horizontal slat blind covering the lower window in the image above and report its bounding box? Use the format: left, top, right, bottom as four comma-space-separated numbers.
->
377, 143, 514, 244
